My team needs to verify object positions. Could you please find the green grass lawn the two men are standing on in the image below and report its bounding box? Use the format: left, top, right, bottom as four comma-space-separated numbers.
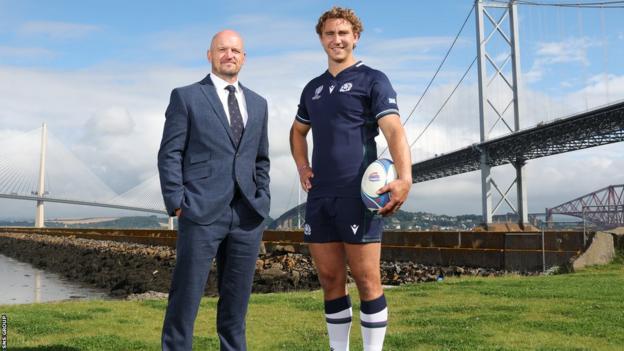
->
0, 257, 624, 351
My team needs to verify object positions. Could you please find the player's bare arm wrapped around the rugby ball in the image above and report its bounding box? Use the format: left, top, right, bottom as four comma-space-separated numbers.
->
377, 114, 412, 216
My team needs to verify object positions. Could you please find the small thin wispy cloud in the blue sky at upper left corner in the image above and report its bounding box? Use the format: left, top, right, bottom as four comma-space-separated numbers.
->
17, 21, 101, 39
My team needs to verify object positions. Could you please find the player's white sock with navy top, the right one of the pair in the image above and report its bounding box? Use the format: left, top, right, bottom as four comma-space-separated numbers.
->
360, 294, 388, 351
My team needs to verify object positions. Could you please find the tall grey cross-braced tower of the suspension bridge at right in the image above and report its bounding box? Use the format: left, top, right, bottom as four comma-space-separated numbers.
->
475, 0, 529, 228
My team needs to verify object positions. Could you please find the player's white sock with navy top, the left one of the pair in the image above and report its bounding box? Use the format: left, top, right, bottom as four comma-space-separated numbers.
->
325, 295, 352, 351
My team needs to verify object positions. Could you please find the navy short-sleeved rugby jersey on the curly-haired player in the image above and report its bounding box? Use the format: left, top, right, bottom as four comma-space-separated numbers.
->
296, 62, 399, 198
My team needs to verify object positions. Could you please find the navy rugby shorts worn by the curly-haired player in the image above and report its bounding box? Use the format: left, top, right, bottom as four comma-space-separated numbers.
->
303, 197, 383, 244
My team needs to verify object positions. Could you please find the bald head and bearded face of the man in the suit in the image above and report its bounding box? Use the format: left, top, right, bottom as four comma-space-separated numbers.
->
208, 29, 245, 83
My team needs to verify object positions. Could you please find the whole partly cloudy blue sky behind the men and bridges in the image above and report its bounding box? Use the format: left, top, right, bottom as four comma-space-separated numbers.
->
0, 0, 624, 218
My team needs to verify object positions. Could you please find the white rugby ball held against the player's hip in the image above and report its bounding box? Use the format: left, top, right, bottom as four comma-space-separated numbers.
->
360, 158, 396, 212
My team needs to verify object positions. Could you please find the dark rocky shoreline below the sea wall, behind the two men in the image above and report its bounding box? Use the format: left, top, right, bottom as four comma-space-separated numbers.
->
0, 233, 528, 298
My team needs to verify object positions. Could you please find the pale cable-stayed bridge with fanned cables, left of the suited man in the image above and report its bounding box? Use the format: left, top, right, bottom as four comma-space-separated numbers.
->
0, 125, 167, 226
